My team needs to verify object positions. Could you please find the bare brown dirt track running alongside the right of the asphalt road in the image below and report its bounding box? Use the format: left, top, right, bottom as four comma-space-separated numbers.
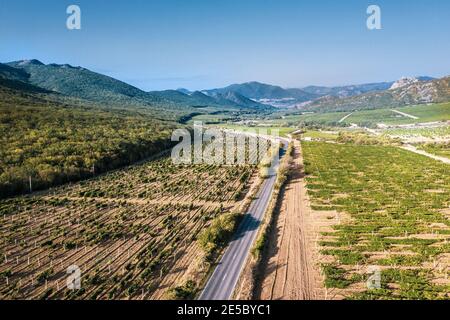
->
256, 142, 323, 300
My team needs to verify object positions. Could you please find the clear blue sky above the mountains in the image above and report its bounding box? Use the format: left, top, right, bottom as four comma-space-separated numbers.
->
0, 0, 450, 90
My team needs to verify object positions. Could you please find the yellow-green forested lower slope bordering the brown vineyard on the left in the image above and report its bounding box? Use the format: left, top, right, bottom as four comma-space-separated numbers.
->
0, 82, 175, 197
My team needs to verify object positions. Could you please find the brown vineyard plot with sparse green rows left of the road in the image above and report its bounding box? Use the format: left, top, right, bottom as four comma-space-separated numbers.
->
0, 149, 257, 299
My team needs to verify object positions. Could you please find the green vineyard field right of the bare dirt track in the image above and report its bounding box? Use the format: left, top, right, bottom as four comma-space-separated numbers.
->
302, 142, 450, 299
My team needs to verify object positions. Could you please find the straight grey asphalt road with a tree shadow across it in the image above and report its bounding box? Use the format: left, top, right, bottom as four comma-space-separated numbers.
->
199, 141, 286, 300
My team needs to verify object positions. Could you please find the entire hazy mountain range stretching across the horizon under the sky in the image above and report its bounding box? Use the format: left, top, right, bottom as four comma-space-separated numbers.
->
0, 60, 450, 117
